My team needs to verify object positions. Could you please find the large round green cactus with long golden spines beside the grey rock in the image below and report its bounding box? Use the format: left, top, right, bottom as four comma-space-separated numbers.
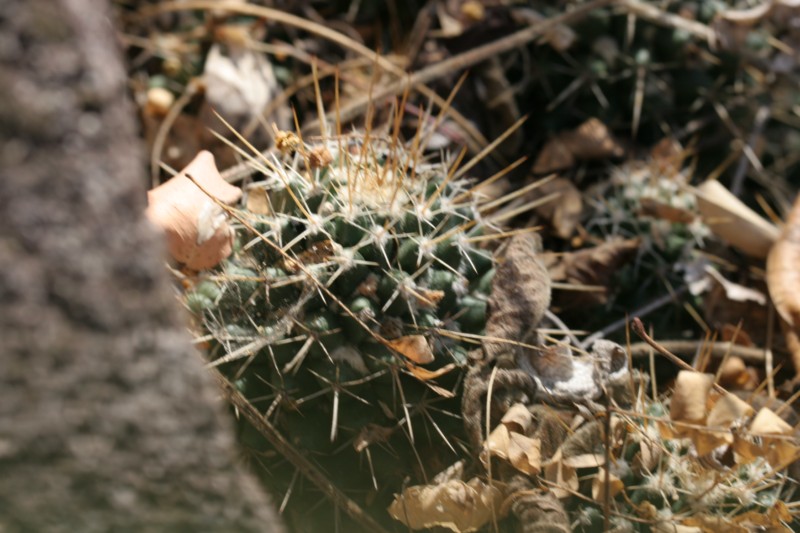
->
185, 114, 512, 516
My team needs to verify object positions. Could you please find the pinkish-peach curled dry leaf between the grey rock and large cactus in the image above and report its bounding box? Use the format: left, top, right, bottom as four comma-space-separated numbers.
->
146, 151, 242, 270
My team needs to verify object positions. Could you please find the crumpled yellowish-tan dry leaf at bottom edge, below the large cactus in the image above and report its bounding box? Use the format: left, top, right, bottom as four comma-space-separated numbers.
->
389, 478, 503, 532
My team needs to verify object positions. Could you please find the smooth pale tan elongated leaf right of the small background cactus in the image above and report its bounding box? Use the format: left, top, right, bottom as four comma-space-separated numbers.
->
694, 180, 780, 259
